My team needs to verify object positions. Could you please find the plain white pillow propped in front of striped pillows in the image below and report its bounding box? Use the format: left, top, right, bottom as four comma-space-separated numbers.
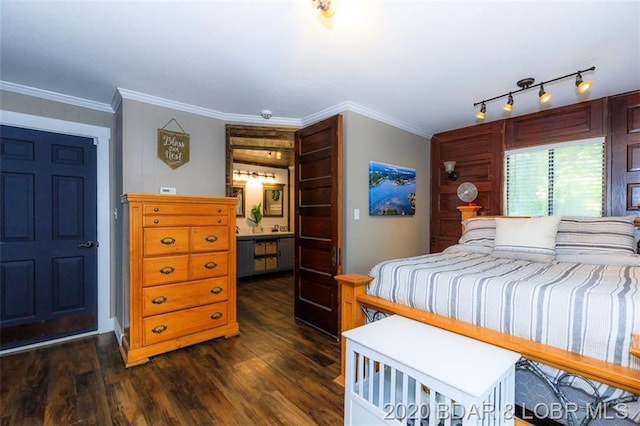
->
491, 216, 560, 262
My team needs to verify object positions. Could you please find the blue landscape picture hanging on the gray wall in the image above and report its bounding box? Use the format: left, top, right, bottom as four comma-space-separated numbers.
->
369, 161, 416, 216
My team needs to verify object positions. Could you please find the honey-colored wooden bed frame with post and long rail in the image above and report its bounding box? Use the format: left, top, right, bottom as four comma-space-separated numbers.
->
335, 210, 640, 395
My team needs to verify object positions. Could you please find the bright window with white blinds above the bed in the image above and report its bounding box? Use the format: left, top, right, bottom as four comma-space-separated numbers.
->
504, 137, 605, 216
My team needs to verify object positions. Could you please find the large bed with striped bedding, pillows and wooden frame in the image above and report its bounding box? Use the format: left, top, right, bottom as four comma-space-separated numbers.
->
336, 216, 640, 425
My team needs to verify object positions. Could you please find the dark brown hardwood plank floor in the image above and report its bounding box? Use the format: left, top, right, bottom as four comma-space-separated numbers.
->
0, 274, 344, 426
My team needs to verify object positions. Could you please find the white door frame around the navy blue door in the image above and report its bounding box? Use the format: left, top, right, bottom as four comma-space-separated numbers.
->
0, 110, 114, 354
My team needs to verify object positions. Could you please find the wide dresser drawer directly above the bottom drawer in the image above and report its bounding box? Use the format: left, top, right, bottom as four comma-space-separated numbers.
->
142, 277, 228, 317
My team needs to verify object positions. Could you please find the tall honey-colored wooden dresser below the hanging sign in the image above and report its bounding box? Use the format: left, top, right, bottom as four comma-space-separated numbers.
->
120, 193, 239, 367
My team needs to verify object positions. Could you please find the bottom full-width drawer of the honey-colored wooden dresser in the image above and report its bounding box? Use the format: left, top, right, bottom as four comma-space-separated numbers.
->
142, 302, 229, 345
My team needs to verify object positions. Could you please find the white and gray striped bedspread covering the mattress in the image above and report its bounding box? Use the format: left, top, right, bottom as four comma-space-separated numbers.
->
367, 245, 640, 392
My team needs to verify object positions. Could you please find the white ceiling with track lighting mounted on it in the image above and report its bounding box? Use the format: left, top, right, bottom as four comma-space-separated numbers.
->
0, 0, 640, 137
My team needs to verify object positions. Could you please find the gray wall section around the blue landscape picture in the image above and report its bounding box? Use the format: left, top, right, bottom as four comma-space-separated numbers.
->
342, 111, 430, 274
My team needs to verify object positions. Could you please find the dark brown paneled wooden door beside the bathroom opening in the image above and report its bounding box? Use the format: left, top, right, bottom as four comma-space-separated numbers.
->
294, 115, 342, 337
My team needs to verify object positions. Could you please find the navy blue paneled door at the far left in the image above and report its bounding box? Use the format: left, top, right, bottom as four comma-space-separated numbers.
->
0, 126, 98, 349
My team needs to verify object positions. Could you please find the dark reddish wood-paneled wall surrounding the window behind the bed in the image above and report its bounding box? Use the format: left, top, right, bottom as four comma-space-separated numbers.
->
430, 91, 640, 253
